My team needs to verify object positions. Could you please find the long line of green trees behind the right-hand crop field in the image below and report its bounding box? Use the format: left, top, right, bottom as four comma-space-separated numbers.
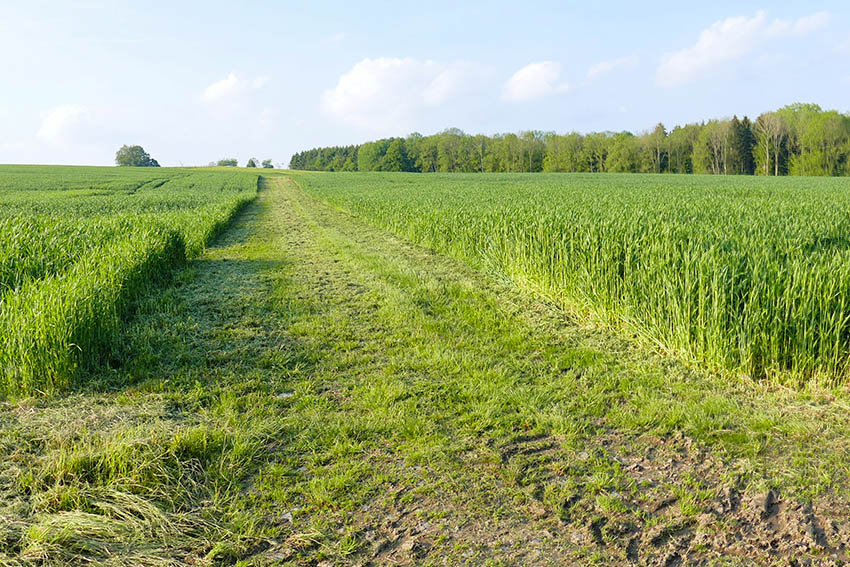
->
289, 103, 850, 175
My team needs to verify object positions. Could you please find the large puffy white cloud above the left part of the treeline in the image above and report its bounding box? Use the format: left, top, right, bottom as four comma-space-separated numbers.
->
321, 57, 485, 131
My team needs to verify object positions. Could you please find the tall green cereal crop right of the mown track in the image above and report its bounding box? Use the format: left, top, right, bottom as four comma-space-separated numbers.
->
296, 173, 850, 384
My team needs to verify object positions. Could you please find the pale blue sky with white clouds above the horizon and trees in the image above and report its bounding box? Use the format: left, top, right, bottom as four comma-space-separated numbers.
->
0, 0, 850, 166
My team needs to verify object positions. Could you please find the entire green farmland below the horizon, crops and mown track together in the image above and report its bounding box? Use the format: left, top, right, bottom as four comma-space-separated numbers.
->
0, 170, 850, 567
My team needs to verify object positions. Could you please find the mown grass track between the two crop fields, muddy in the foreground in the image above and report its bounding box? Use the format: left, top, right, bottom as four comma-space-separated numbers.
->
0, 177, 850, 567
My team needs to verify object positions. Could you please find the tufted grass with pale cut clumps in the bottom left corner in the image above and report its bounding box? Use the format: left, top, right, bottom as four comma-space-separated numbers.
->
0, 398, 280, 565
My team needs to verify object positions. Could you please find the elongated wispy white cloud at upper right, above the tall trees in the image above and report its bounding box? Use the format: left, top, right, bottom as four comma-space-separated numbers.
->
655, 10, 829, 86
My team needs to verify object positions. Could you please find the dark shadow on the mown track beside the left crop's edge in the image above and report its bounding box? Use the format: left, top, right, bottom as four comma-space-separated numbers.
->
75, 190, 312, 394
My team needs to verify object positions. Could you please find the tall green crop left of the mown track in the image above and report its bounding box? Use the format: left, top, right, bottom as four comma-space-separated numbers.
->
0, 166, 258, 394
